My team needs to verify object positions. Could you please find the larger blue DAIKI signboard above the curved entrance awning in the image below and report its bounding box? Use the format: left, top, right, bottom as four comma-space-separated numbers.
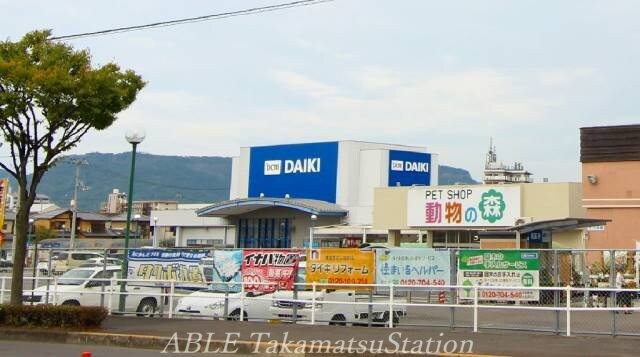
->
249, 142, 338, 203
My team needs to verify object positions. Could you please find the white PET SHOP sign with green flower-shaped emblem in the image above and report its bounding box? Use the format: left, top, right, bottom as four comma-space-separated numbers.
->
407, 186, 521, 227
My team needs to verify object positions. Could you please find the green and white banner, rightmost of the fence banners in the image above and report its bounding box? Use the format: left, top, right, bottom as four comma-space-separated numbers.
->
458, 250, 540, 301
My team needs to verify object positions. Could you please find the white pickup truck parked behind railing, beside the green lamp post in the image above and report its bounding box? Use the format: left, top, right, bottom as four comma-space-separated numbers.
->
22, 265, 161, 317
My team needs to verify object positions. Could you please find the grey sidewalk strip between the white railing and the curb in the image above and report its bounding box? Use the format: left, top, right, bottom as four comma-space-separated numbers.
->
97, 317, 640, 357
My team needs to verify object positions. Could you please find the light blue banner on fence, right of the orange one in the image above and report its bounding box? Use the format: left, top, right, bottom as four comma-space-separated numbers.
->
376, 248, 451, 291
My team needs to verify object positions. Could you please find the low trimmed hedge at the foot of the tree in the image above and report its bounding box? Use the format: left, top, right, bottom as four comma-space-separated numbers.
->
0, 305, 108, 328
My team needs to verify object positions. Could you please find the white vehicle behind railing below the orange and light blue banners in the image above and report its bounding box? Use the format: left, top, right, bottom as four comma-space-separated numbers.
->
271, 290, 406, 325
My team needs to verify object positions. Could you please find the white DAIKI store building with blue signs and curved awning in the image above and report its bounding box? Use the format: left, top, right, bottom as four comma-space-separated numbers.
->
197, 141, 438, 248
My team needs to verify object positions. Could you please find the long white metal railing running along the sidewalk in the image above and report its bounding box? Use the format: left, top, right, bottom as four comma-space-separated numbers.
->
0, 276, 640, 336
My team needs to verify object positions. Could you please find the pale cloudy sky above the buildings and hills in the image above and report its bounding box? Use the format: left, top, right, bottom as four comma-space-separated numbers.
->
0, 0, 640, 181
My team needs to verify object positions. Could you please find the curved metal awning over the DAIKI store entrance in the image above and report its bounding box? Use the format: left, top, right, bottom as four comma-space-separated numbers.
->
196, 197, 348, 217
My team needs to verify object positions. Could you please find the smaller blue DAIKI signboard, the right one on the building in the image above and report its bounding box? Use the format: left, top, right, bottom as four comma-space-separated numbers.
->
389, 150, 431, 186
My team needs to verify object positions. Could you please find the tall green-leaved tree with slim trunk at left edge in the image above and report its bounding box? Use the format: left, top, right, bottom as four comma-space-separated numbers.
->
0, 30, 145, 305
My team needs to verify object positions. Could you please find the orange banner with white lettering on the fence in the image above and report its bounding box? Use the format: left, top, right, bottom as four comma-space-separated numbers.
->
307, 248, 375, 289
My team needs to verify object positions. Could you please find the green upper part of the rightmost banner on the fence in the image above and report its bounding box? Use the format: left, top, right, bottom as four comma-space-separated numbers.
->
458, 250, 540, 270
